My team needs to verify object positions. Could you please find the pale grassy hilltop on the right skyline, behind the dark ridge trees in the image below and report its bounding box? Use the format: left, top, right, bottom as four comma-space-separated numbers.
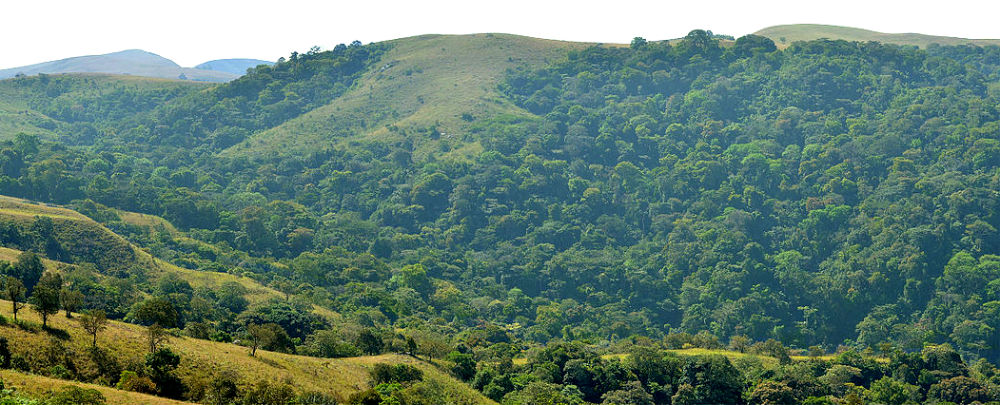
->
754, 24, 1000, 48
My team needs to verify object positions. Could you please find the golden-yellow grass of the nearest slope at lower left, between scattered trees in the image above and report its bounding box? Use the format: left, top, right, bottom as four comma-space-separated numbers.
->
0, 301, 492, 404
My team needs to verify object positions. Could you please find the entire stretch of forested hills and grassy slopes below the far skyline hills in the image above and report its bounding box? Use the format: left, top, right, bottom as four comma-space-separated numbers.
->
0, 24, 1000, 405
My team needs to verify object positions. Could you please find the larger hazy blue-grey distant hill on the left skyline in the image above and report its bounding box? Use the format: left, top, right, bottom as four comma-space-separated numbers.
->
0, 49, 245, 82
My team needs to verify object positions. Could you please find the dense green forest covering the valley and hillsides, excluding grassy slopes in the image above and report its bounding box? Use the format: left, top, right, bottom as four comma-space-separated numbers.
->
0, 30, 1000, 404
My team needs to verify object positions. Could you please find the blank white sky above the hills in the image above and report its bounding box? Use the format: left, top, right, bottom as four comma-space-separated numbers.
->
0, 0, 1000, 69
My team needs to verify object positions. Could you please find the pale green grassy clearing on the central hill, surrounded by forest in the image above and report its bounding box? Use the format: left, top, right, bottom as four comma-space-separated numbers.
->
222, 34, 592, 160
